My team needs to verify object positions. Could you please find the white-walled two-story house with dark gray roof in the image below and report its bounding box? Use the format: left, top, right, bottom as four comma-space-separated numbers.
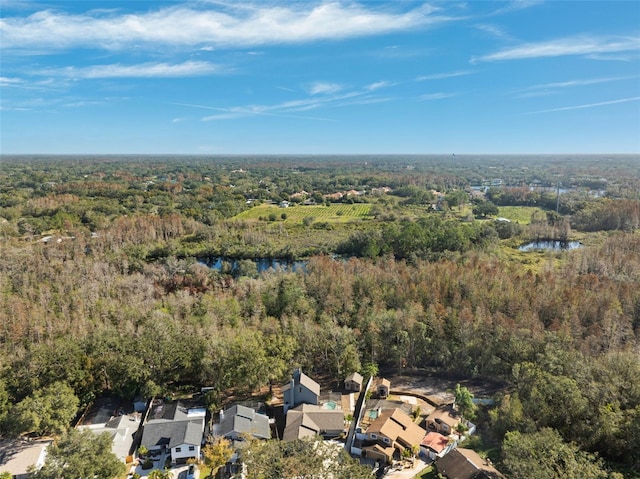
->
142, 401, 206, 464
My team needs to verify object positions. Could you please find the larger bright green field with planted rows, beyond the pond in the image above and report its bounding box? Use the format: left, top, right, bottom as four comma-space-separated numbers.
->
233, 203, 371, 223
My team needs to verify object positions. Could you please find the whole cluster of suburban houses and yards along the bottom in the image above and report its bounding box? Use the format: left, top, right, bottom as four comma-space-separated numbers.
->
0, 368, 504, 479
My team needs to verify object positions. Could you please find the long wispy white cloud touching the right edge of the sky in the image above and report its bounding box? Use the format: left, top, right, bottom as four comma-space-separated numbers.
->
471, 36, 640, 63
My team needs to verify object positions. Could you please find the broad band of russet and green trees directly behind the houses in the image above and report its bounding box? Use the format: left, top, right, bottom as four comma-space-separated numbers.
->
0, 232, 640, 467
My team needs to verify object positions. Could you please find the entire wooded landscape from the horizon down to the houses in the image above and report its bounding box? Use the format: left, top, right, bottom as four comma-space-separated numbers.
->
0, 156, 640, 478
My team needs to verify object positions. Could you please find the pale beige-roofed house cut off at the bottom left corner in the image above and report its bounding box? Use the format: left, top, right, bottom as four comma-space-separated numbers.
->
0, 439, 51, 479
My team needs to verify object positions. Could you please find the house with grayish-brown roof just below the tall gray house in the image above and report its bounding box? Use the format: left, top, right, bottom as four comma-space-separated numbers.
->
282, 404, 345, 441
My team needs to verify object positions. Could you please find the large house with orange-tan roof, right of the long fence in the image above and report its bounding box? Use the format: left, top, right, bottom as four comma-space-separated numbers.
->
363, 408, 427, 462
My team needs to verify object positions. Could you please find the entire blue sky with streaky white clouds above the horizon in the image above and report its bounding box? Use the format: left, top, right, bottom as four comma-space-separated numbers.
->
0, 0, 640, 154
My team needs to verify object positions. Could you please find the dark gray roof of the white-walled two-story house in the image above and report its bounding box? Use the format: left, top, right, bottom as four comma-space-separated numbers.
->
142, 418, 204, 449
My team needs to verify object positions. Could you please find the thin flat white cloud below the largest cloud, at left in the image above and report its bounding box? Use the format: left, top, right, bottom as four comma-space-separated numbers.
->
34, 61, 220, 79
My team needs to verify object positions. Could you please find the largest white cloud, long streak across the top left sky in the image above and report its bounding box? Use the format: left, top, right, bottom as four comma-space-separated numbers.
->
0, 2, 452, 49
